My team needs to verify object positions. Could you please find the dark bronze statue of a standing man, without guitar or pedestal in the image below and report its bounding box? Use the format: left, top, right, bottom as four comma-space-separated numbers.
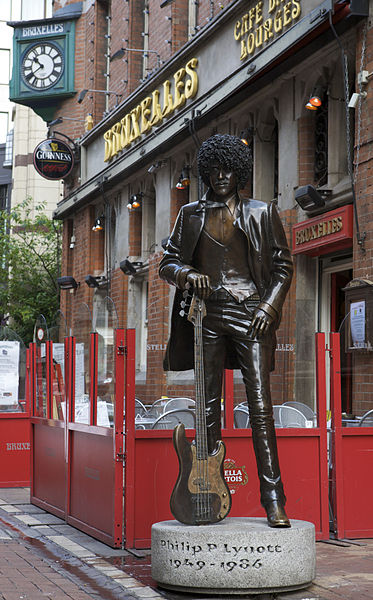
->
159, 135, 293, 527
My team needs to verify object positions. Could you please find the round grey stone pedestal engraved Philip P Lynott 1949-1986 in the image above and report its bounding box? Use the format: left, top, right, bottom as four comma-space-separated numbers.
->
152, 517, 316, 595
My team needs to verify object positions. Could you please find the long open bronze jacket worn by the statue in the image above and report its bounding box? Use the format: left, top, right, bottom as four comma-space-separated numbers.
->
159, 196, 293, 371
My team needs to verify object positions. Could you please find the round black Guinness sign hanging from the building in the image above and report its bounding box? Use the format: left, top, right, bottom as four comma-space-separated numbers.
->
34, 138, 74, 180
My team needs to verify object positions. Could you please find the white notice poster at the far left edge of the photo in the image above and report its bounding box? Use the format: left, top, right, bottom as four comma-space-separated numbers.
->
0, 341, 19, 410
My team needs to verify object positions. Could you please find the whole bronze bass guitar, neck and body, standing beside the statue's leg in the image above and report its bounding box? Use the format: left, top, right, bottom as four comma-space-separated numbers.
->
170, 294, 231, 525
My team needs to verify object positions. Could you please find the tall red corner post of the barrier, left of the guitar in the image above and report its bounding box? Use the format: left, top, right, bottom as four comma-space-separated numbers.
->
114, 329, 125, 547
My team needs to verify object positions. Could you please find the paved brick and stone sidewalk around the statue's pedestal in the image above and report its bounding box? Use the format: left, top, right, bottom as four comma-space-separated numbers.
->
0, 488, 373, 600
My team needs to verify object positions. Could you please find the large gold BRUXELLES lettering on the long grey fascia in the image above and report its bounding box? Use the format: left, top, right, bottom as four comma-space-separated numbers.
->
104, 58, 198, 162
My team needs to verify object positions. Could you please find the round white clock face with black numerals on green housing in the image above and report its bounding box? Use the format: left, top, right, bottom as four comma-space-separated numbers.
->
21, 42, 64, 91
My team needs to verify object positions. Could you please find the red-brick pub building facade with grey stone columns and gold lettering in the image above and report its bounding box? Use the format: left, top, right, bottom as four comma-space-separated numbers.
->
41, 0, 373, 422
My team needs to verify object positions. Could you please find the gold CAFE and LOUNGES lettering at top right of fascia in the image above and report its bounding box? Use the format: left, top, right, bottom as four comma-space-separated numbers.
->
234, 0, 301, 60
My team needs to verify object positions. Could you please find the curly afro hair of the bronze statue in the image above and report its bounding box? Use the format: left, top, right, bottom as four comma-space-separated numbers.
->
197, 133, 252, 189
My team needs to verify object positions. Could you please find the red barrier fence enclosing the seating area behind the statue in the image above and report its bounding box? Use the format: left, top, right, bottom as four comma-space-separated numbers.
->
30, 329, 373, 548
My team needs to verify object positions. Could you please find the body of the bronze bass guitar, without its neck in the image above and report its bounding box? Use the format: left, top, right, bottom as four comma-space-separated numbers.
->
170, 423, 231, 525
